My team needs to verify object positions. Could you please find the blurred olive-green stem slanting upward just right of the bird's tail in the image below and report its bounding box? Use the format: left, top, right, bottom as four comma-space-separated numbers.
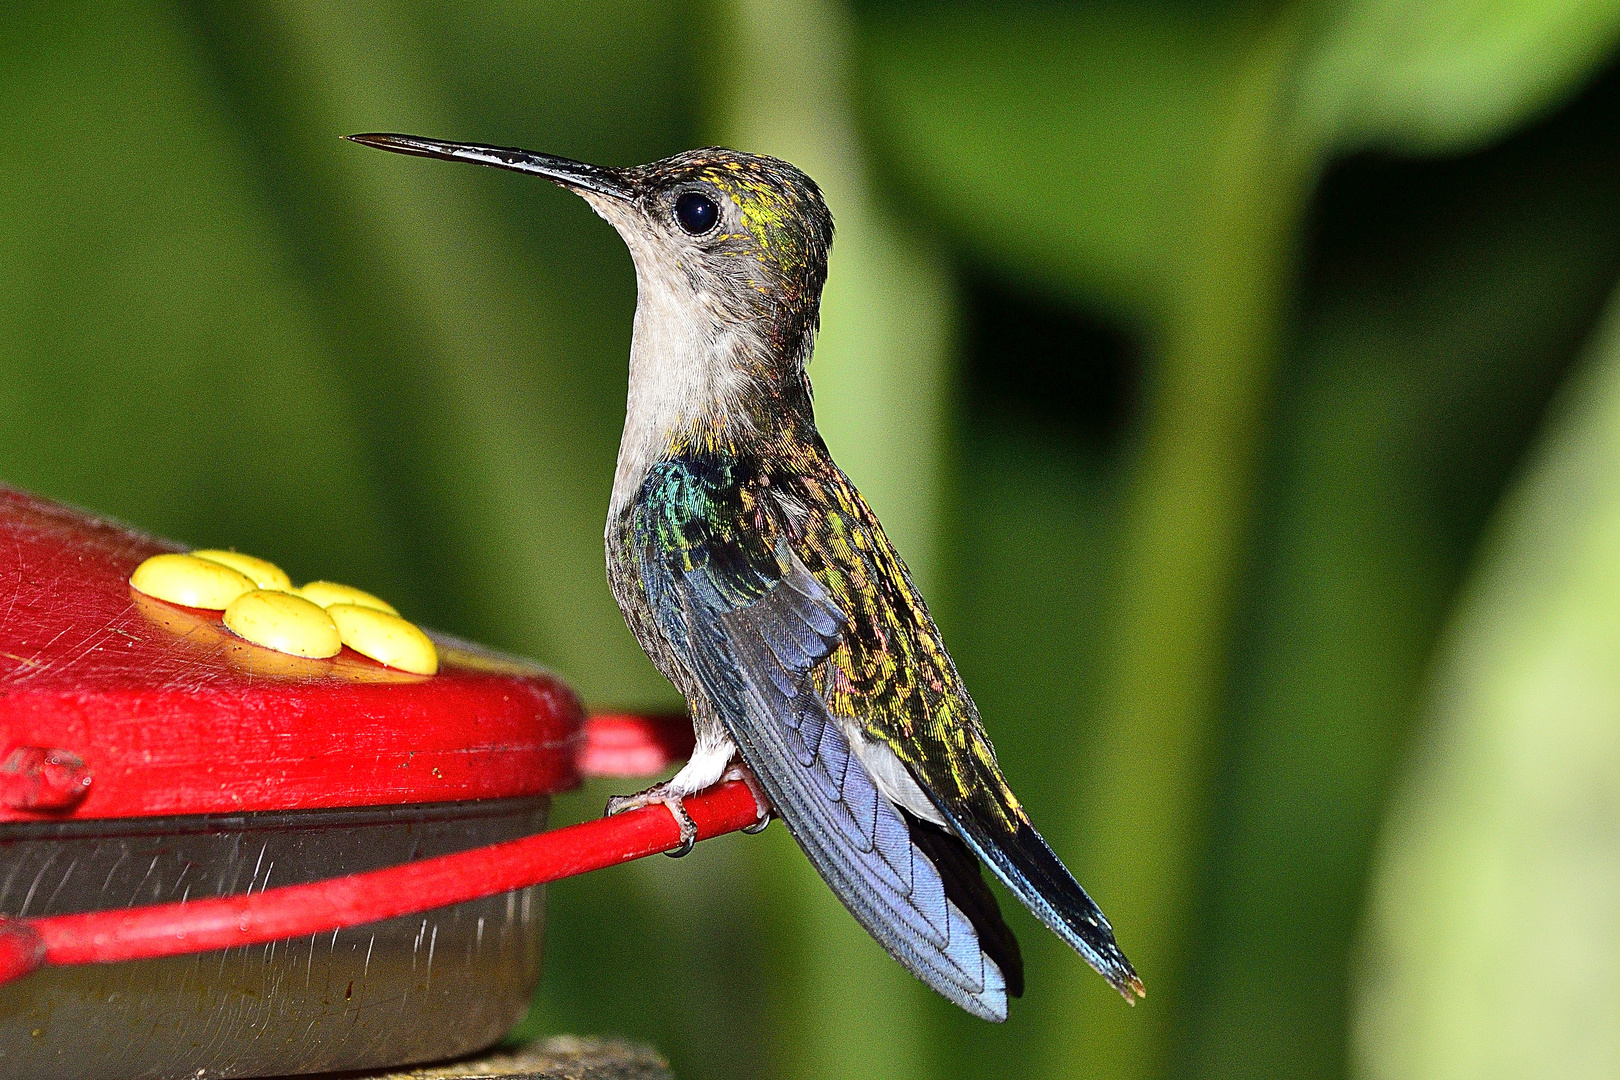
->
1047, 13, 1311, 1078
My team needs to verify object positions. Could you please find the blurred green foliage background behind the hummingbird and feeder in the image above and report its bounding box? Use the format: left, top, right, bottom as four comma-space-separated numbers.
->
0, 0, 1620, 1080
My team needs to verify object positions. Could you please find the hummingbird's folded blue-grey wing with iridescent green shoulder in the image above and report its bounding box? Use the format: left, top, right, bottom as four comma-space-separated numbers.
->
627, 457, 1021, 1020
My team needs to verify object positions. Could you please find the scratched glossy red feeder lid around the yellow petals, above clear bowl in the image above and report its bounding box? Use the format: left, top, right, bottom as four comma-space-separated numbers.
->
0, 487, 583, 823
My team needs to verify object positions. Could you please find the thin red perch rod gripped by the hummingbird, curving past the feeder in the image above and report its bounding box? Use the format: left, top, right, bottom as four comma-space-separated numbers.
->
0, 717, 758, 983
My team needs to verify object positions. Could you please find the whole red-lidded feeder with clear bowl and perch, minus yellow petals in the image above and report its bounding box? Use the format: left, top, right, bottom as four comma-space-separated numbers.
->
0, 487, 755, 1078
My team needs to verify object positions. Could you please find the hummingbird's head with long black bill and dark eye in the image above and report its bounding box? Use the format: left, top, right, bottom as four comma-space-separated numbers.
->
348, 134, 833, 381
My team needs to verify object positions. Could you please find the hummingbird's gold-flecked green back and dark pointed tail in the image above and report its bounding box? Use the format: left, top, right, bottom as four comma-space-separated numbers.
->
790, 450, 1142, 1001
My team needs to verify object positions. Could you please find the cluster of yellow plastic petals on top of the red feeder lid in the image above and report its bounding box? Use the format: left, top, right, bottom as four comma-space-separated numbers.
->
130, 549, 439, 675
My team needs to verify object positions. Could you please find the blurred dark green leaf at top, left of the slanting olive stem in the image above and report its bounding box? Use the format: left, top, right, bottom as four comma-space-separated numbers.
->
862, 3, 1244, 314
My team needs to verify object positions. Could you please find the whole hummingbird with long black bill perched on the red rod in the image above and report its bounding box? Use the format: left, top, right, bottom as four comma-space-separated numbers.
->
347, 134, 1145, 1022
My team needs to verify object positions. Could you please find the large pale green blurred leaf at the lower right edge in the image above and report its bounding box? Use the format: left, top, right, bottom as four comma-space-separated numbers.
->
1353, 262, 1620, 1078
